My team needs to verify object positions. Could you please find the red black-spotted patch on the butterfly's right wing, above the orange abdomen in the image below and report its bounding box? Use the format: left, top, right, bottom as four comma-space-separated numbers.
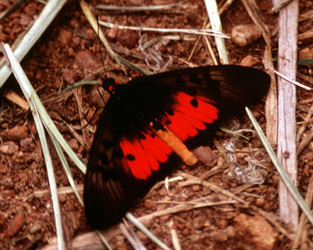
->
167, 92, 218, 141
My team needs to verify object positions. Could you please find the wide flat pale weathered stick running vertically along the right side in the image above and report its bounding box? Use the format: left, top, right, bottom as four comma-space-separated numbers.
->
273, 0, 299, 230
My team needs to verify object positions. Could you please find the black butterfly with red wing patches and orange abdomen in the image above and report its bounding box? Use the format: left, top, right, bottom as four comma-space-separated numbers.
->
84, 65, 270, 229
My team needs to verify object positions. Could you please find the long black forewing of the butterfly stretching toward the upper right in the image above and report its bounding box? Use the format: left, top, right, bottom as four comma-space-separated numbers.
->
130, 65, 270, 110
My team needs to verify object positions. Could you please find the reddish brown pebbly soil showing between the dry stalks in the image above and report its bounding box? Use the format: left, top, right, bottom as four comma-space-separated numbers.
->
0, 0, 313, 249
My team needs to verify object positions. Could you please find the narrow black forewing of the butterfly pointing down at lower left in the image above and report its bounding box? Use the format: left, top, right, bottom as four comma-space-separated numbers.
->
84, 106, 130, 228
